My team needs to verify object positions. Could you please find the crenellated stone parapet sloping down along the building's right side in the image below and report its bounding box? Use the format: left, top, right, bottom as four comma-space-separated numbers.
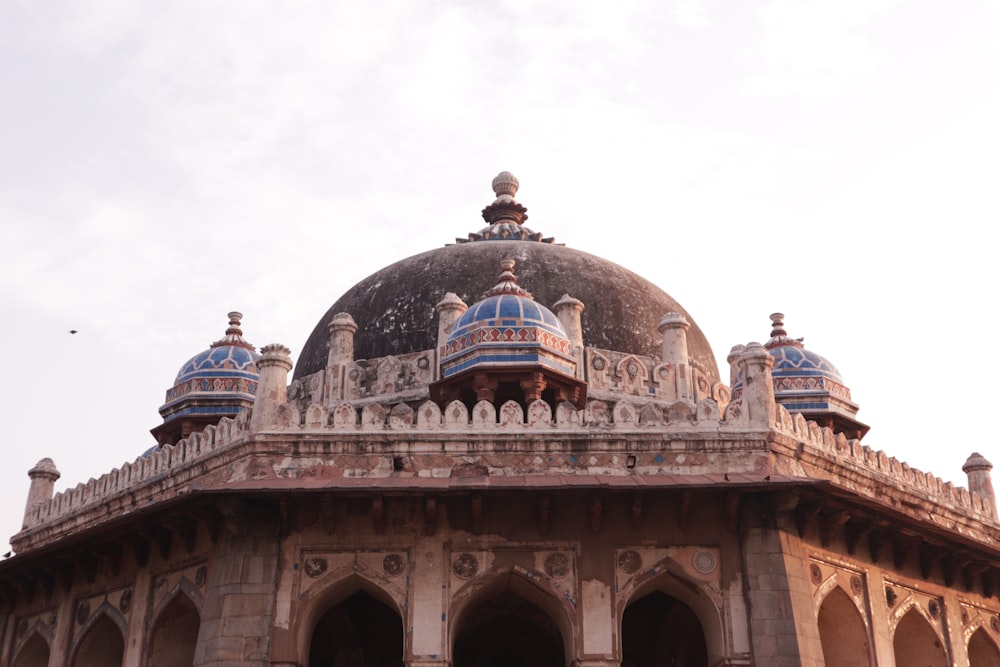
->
768, 401, 997, 523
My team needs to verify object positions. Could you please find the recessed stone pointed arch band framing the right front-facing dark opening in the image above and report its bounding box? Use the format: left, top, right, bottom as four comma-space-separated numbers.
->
617, 558, 726, 665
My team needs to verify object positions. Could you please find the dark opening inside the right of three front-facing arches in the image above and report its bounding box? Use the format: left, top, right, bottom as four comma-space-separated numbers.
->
622, 591, 708, 667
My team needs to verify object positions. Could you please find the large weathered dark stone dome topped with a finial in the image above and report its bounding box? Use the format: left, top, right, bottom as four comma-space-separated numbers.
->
295, 174, 719, 382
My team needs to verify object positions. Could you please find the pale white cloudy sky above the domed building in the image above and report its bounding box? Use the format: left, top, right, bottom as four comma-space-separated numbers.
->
0, 0, 1000, 552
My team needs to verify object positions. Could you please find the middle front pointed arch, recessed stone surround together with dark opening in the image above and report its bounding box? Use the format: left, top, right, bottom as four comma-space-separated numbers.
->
448, 570, 576, 667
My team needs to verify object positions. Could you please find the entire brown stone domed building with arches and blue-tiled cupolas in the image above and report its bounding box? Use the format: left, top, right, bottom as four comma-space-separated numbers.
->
0, 172, 1000, 667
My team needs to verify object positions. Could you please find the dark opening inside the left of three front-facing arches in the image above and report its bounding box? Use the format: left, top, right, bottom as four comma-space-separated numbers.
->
309, 591, 403, 667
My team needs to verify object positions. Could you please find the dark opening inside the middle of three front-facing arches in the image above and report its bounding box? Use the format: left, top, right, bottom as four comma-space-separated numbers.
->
452, 588, 566, 667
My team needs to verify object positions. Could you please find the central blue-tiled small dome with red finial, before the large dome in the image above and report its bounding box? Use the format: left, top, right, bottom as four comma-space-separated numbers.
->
441, 260, 576, 378
